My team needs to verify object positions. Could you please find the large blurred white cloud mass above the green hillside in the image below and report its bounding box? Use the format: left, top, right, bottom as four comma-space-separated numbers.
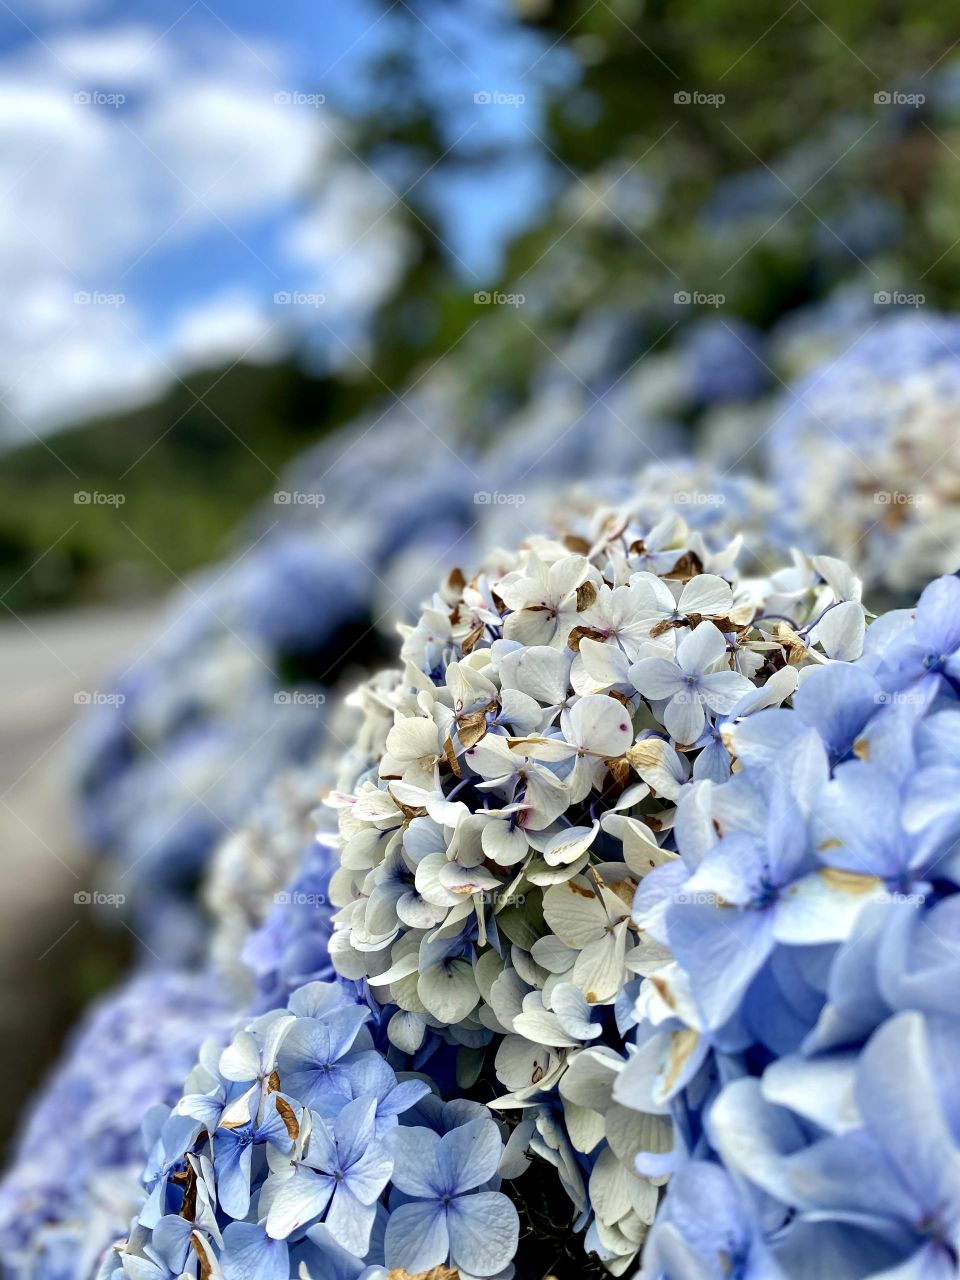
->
0, 23, 403, 450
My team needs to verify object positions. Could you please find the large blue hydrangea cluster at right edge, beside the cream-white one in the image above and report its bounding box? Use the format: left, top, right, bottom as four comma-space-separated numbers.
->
616, 577, 960, 1280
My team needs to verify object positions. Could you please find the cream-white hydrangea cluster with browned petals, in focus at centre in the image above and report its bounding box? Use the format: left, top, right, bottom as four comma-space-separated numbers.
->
323, 509, 865, 1274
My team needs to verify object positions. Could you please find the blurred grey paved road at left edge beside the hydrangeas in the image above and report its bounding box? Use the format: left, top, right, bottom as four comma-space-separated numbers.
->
0, 608, 155, 1146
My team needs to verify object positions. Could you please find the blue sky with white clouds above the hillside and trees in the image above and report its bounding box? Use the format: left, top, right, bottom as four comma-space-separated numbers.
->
0, 0, 575, 442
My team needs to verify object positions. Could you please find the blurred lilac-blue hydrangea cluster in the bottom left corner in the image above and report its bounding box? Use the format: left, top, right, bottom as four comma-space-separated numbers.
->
0, 973, 234, 1280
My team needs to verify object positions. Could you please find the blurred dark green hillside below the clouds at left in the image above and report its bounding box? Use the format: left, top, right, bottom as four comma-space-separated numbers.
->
0, 362, 345, 611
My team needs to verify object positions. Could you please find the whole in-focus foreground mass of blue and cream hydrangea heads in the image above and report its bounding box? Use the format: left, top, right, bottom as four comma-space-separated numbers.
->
56, 478, 960, 1280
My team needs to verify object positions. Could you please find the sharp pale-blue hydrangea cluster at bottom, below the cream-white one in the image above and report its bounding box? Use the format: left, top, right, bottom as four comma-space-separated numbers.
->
99, 982, 522, 1280
